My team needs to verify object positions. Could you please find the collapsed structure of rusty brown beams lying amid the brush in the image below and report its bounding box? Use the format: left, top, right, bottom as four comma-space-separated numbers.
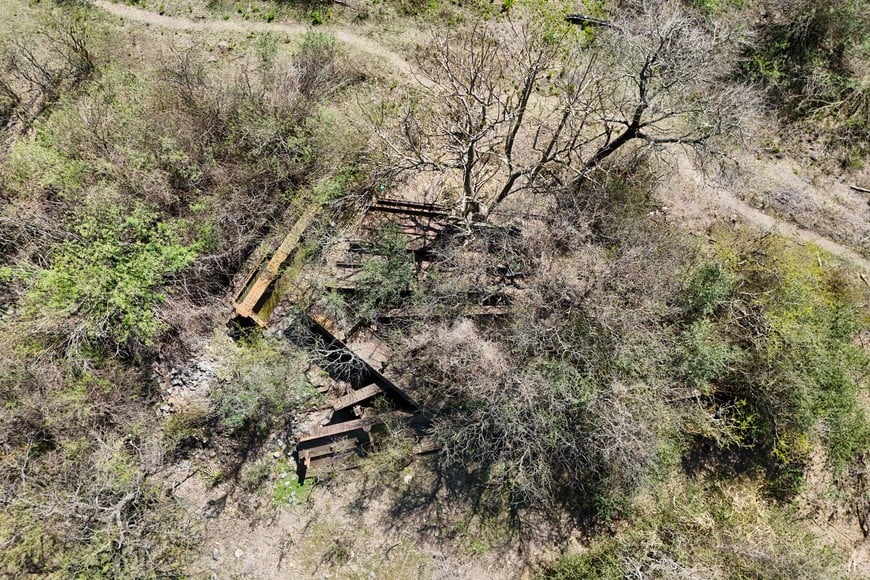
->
232, 198, 451, 479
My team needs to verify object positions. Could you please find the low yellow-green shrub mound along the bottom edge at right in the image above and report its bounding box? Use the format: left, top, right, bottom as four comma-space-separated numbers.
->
542, 480, 843, 580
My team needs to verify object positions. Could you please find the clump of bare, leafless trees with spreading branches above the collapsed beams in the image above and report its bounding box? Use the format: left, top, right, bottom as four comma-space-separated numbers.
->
376, 5, 742, 220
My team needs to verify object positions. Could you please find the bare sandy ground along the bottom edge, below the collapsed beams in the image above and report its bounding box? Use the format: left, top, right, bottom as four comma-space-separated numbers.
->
160, 460, 540, 580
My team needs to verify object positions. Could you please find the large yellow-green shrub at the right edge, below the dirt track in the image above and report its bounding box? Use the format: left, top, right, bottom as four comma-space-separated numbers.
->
680, 236, 870, 495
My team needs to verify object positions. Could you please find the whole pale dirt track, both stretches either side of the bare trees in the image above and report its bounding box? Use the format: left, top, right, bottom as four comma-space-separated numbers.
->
91, 0, 870, 272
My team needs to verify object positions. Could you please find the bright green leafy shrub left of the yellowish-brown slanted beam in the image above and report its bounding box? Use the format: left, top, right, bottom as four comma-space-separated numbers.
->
26, 190, 197, 345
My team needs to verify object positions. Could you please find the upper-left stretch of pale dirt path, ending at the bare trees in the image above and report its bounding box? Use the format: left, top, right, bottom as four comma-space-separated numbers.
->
92, 0, 428, 85
